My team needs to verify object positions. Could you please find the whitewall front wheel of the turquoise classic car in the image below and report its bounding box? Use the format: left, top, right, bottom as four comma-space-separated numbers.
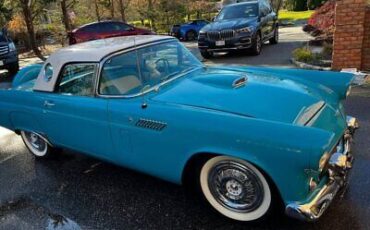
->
200, 156, 271, 221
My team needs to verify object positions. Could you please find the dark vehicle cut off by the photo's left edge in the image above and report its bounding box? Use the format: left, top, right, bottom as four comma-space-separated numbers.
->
0, 29, 19, 76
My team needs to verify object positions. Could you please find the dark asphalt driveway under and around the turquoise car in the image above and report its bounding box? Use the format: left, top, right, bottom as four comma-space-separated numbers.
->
0, 26, 370, 230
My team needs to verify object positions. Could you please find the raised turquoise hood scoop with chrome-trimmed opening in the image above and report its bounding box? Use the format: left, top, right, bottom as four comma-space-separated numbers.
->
193, 73, 248, 89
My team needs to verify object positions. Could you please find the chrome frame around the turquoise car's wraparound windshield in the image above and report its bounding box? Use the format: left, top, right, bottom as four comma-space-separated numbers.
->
95, 38, 204, 98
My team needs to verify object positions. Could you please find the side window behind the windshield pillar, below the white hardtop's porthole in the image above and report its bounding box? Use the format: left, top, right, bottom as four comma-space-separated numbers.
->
56, 63, 96, 96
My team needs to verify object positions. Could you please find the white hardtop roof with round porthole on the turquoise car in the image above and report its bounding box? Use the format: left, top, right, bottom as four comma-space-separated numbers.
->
33, 35, 176, 92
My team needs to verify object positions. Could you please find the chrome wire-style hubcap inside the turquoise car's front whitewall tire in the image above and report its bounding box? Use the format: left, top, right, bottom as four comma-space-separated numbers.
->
208, 161, 263, 213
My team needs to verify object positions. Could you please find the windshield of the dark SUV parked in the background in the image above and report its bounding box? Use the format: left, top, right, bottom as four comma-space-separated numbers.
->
215, 3, 258, 21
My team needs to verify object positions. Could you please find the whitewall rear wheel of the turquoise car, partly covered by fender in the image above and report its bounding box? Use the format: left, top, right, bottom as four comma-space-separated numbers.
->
21, 131, 58, 158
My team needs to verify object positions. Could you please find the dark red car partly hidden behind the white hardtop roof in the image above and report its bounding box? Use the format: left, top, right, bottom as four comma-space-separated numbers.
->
68, 21, 155, 45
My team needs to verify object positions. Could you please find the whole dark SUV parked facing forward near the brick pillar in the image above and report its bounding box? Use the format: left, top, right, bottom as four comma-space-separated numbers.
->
198, 0, 279, 58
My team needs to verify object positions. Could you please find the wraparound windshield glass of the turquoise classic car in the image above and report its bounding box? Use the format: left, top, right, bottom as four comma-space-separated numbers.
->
99, 41, 203, 95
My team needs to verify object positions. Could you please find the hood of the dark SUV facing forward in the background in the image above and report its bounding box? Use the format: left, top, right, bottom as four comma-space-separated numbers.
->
202, 18, 257, 31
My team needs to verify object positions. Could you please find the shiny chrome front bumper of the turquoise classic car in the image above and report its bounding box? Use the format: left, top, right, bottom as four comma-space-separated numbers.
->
285, 116, 359, 221
